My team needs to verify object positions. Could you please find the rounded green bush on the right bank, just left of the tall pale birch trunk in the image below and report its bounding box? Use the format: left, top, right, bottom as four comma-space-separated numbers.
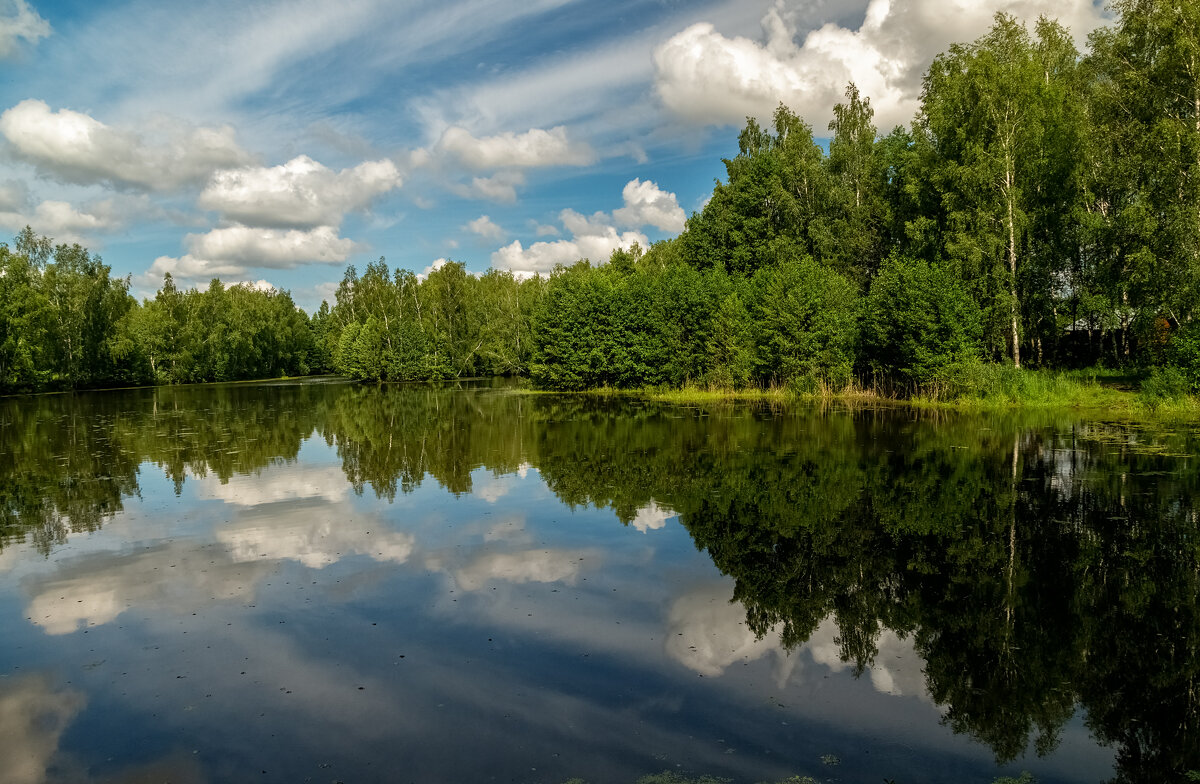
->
862, 258, 982, 385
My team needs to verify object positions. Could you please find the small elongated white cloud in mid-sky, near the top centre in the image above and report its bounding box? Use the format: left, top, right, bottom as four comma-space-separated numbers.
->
437, 125, 596, 169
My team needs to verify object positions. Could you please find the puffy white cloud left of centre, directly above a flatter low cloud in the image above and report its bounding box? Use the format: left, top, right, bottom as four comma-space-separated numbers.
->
199, 155, 401, 228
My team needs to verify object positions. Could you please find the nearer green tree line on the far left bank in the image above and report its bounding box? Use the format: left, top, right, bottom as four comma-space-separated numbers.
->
0, 227, 318, 393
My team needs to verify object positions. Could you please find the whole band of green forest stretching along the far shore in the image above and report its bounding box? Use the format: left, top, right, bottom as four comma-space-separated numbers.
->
0, 0, 1200, 395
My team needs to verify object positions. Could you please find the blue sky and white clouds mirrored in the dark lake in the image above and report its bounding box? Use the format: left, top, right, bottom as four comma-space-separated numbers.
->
0, 384, 1180, 784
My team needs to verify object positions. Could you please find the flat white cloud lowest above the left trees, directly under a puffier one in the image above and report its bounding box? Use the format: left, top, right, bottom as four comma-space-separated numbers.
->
148, 226, 358, 282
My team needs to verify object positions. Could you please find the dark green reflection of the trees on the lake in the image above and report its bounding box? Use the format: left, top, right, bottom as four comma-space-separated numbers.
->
0, 383, 1200, 782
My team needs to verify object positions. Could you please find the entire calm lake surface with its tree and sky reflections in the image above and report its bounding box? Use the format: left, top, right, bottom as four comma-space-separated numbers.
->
0, 383, 1200, 784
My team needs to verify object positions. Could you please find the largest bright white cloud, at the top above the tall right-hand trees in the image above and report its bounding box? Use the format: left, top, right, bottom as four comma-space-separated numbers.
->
654, 0, 1105, 130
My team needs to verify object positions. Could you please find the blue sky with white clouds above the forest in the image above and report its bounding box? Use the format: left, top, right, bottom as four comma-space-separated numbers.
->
0, 0, 1109, 312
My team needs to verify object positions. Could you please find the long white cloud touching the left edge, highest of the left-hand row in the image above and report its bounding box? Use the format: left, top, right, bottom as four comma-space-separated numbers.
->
0, 100, 250, 190
